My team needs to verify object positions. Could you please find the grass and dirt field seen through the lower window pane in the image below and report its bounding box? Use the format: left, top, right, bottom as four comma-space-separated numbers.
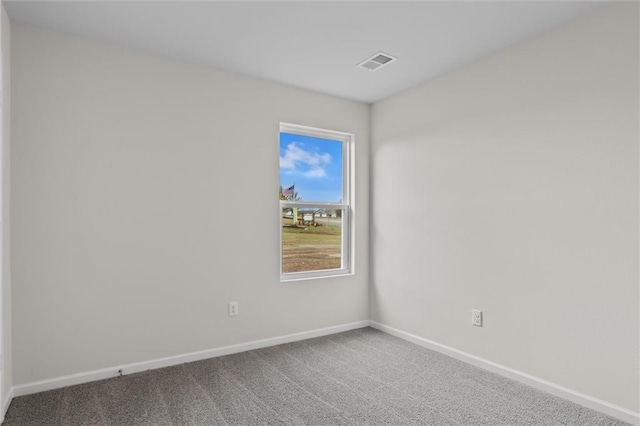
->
282, 218, 342, 273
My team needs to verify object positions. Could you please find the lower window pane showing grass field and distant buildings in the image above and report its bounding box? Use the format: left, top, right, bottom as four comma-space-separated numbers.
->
282, 208, 343, 273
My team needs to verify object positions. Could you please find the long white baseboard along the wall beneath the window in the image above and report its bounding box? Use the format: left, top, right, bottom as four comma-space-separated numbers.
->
12, 320, 369, 400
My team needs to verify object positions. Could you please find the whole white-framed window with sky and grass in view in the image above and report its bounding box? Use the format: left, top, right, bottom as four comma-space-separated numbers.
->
279, 124, 353, 281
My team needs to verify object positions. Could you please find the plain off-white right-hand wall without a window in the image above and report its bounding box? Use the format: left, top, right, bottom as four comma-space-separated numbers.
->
371, 3, 640, 411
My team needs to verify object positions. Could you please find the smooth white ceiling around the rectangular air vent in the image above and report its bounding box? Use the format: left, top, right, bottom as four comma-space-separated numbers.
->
4, 0, 603, 103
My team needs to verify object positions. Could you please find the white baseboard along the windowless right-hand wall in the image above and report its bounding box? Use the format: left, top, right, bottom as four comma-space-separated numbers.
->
370, 321, 640, 425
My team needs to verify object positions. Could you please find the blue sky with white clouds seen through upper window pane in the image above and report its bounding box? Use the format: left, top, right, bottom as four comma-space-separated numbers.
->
280, 133, 342, 203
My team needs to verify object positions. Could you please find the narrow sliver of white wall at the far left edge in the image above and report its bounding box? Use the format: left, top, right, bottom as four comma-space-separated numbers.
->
0, 5, 12, 410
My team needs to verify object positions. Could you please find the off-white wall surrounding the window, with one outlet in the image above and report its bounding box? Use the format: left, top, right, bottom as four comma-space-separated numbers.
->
11, 24, 369, 385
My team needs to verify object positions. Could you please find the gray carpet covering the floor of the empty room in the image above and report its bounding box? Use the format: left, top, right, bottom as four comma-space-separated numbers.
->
3, 328, 625, 425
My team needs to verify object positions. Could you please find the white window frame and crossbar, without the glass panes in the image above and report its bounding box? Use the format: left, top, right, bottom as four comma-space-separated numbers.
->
278, 123, 355, 281
